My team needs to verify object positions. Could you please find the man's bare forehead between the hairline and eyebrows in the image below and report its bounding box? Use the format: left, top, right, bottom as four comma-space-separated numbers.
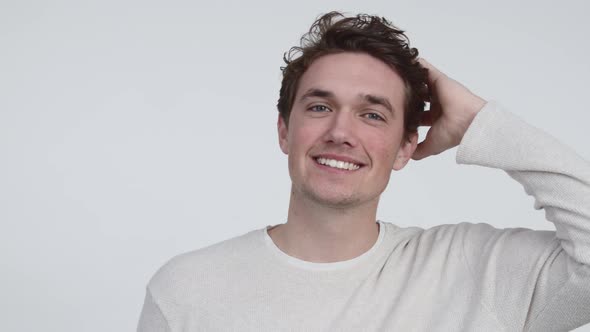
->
296, 53, 405, 109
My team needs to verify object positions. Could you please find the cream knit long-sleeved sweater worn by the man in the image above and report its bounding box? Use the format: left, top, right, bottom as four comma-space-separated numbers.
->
138, 102, 590, 332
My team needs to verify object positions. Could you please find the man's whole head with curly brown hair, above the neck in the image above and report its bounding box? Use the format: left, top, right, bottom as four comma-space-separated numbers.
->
278, 13, 425, 207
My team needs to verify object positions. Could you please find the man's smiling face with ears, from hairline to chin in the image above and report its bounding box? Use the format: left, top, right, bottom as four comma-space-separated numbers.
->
278, 53, 417, 207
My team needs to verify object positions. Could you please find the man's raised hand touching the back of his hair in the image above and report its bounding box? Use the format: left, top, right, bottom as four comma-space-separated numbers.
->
412, 59, 486, 160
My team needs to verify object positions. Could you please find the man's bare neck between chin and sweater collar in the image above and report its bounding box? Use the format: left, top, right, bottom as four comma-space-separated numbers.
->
269, 191, 379, 263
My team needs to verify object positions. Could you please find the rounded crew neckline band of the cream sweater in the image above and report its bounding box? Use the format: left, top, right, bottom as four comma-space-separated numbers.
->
262, 220, 387, 271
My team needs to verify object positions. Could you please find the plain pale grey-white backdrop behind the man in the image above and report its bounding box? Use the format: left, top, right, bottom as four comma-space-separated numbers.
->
0, 0, 590, 331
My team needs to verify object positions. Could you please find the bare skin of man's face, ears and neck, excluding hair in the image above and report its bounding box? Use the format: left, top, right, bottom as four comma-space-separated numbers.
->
269, 52, 417, 262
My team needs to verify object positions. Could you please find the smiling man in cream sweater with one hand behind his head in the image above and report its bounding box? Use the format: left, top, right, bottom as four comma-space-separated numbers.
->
138, 13, 590, 331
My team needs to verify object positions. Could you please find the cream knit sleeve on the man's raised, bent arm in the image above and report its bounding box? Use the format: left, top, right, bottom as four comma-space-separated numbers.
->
457, 102, 590, 331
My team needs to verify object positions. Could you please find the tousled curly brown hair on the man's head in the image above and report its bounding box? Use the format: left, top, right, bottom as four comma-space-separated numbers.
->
277, 11, 428, 139
